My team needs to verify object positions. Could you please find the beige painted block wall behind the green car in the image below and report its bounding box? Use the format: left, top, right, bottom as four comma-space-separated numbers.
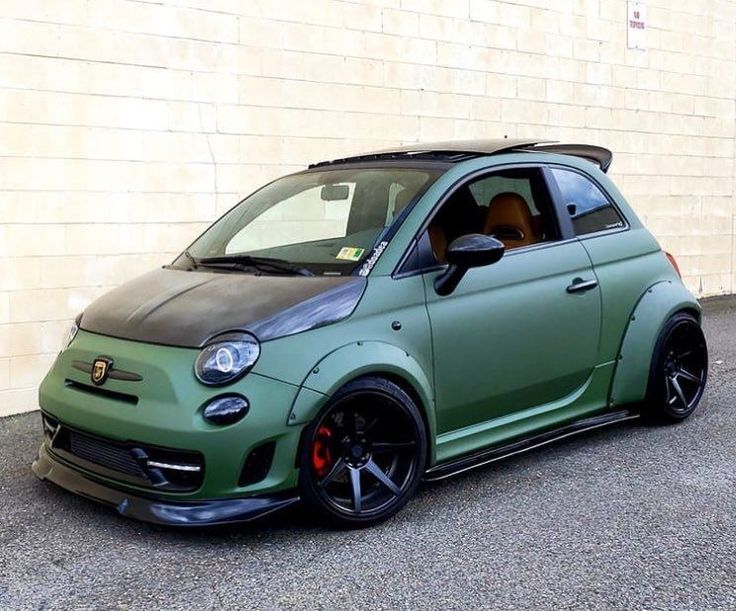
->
0, 0, 736, 415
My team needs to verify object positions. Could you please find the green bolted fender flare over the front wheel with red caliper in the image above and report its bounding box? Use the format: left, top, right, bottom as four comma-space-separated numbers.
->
288, 341, 436, 462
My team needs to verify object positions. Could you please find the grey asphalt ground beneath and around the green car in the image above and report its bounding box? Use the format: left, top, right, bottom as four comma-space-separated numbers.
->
0, 298, 736, 609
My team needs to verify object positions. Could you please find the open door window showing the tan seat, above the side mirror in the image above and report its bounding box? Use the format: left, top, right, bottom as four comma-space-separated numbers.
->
427, 168, 560, 263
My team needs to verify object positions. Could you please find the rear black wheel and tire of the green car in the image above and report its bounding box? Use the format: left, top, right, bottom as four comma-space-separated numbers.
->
644, 312, 708, 422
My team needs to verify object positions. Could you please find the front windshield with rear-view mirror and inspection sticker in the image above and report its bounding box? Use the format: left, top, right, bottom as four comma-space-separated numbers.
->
177, 167, 443, 275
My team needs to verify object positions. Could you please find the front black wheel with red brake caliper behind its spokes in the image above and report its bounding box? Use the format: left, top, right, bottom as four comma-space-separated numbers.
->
299, 377, 427, 528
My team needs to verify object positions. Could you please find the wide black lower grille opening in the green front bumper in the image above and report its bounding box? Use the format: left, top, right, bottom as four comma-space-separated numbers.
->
43, 414, 204, 492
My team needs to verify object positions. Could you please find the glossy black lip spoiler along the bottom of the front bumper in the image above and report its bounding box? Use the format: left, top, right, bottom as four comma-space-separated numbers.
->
31, 444, 299, 526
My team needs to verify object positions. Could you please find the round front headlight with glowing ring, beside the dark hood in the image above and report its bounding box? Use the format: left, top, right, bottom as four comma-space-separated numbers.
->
194, 333, 261, 386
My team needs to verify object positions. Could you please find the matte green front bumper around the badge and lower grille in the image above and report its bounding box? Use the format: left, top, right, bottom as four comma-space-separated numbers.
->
39, 331, 322, 507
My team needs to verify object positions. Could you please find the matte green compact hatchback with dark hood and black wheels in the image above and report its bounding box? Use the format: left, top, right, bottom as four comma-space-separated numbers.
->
33, 139, 708, 527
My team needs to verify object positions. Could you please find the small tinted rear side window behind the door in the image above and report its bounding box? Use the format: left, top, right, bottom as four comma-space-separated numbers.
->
552, 168, 624, 235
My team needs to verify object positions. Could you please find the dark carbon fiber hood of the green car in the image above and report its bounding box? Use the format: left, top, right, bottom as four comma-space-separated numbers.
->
81, 268, 366, 348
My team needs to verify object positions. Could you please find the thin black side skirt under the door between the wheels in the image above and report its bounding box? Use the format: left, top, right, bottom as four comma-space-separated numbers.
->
424, 409, 639, 482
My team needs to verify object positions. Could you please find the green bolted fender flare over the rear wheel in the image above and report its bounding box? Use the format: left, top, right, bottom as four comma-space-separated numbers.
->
609, 280, 700, 405
